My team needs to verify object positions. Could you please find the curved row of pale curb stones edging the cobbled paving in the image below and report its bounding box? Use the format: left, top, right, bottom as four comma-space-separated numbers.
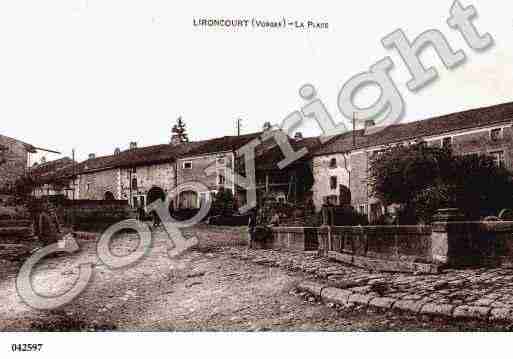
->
297, 281, 513, 322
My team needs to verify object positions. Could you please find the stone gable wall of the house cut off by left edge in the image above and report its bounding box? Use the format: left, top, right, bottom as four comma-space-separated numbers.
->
0, 135, 28, 188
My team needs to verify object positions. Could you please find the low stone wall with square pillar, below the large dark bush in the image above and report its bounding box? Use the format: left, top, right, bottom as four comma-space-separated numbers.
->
269, 221, 513, 273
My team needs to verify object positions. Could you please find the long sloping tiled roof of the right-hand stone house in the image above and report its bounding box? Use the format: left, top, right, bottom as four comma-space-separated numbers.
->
315, 102, 513, 155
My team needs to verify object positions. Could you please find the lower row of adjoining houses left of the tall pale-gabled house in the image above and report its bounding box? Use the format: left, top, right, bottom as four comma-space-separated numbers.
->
31, 132, 320, 208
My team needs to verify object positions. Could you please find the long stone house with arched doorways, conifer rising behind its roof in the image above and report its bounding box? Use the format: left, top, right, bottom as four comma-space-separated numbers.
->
62, 133, 259, 212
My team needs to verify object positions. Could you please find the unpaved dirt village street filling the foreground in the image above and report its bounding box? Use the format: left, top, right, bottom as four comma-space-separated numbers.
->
0, 226, 509, 331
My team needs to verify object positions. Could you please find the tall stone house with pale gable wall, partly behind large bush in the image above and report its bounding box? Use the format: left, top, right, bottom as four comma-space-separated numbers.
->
312, 103, 513, 219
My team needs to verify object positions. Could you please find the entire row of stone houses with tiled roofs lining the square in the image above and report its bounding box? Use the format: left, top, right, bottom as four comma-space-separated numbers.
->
32, 103, 513, 217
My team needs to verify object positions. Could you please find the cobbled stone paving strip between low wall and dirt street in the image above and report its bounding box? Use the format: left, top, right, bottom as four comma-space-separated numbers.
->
226, 248, 513, 322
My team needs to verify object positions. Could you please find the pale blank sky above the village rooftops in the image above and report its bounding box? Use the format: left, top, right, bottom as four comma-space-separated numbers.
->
0, 0, 513, 163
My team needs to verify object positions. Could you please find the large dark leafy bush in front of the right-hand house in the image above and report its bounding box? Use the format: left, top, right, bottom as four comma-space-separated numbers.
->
370, 144, 513, 224
